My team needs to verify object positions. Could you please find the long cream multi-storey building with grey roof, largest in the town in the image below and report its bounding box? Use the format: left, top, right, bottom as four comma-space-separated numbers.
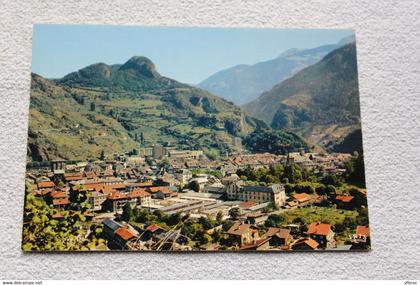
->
226, 181, 287, 206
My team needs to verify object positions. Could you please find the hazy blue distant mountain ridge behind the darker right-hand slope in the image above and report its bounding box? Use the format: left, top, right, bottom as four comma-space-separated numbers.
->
198, 36, 354, 105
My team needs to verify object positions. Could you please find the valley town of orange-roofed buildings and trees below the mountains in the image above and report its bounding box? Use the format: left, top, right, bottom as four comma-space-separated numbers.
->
23, 144, 370, 251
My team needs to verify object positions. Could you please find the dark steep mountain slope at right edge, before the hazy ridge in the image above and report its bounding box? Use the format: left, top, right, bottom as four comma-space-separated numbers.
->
244, 43, 360, 148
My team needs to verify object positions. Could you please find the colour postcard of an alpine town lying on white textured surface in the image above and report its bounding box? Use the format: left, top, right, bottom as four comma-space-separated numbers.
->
22, 25, 370, 252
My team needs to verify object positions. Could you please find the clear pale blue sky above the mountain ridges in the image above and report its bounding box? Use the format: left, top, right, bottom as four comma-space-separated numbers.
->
32, 24, 353, 84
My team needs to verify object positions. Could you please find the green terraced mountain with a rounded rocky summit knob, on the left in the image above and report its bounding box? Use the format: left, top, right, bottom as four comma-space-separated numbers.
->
28, 57, 267, 161
